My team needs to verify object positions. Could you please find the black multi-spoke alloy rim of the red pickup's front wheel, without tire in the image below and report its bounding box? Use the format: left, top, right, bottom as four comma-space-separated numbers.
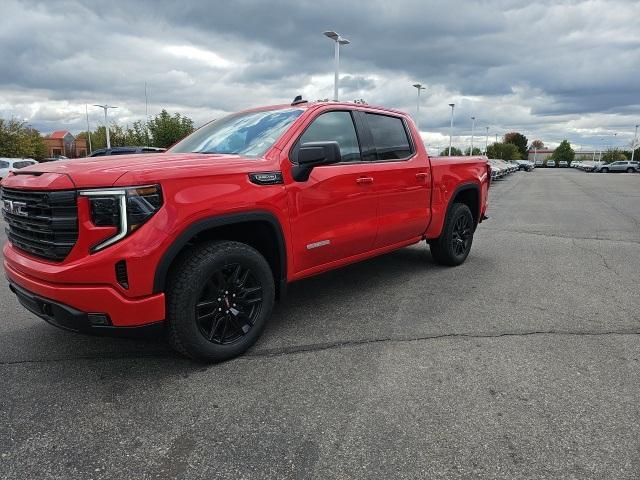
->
195, 263, 262, 345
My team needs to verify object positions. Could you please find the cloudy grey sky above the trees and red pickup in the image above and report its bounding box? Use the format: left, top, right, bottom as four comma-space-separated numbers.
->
0, 0, 640, 149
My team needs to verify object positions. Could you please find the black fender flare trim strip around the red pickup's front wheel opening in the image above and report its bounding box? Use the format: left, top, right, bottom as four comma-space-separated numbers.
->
153, 211, 287, 297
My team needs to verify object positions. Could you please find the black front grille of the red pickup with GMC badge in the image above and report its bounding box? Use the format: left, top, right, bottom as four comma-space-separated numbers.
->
0, 188, 78, 262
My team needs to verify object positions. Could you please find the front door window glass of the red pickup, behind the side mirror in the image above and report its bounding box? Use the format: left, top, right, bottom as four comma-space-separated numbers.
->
298, 112, 361, 163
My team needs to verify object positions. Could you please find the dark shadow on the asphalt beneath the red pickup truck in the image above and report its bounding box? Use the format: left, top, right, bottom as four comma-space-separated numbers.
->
0, 244, 443, 367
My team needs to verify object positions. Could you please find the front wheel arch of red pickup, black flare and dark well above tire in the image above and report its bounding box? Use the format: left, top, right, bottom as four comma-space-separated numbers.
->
153, 211, 287, 298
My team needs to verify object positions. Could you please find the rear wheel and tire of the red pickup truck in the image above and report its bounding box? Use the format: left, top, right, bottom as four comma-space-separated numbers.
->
429, 203, 475, 267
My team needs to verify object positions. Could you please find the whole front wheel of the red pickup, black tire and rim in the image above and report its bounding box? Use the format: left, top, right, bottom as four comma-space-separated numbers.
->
167, 241, 275, 362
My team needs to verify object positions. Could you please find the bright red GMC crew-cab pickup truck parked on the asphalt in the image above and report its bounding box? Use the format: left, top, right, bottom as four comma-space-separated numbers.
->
1, 101, 490, 361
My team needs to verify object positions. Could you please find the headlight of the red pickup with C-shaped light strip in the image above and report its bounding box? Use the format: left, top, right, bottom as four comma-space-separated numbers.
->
79, 185, 162, 252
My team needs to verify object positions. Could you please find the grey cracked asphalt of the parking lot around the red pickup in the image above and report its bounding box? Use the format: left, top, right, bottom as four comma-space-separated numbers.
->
0, 169, 640, 480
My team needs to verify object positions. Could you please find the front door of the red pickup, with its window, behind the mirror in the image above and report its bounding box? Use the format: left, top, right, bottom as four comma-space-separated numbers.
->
287, 110, 378, 273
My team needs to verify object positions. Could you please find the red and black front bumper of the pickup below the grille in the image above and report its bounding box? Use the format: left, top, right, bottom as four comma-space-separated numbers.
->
4, 259, 165, 331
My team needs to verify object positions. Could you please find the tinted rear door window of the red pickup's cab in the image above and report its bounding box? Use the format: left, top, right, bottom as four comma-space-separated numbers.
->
367, 113, 413, 160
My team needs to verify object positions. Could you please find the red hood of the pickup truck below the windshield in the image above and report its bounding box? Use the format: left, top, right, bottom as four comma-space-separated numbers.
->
3, 153, 268, 188
